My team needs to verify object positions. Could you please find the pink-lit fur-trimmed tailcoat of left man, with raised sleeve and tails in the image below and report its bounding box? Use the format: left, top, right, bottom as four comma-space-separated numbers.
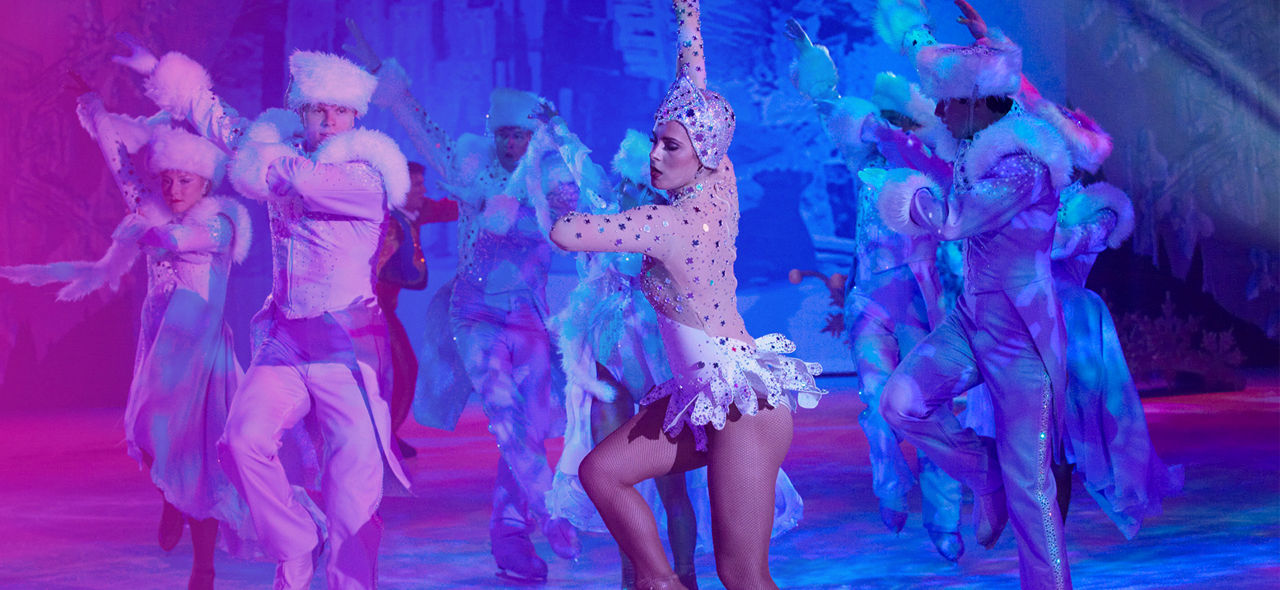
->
146, 54, 410, 488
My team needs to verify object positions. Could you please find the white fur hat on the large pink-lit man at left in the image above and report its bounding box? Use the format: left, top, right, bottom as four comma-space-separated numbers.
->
288, 50, 378, 115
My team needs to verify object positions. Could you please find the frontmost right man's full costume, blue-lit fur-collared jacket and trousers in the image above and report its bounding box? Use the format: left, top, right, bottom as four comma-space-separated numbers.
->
879, 110, 1070, 587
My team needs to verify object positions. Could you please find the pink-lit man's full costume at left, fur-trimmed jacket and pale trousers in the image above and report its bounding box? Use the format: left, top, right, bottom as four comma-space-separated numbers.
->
147, 58, 410, 587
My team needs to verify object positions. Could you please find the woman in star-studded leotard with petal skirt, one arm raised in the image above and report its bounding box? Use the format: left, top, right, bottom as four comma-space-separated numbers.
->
552, 0, 824, 589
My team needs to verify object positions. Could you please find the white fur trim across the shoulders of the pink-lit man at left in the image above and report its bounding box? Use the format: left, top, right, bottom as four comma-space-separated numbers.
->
229, 109, 410, 207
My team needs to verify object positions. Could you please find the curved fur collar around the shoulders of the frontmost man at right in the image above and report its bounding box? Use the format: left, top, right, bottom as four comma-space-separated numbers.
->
964, 113, 1071, 191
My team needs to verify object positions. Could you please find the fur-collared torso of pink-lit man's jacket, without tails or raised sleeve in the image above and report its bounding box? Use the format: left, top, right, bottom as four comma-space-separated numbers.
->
229, 109, 410, 317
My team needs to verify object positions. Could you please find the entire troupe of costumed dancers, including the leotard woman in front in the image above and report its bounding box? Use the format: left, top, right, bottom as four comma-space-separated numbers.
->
0, 0, 1181, 589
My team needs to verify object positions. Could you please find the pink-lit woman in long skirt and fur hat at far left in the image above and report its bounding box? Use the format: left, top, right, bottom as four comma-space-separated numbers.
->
0, 93, 252, 589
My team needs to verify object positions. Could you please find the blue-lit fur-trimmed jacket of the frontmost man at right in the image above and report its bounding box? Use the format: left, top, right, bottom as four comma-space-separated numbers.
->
878, 111, 1071, 392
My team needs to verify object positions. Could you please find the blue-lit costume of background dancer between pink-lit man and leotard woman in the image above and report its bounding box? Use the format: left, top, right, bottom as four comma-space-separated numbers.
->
375, 69, 581, 547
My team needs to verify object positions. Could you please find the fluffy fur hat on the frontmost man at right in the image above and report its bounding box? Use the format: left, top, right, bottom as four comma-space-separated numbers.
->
915, 35, 1023, 100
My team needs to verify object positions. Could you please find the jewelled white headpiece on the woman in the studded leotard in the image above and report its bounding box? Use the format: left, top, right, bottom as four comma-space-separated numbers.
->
653, 72, 735, 168
